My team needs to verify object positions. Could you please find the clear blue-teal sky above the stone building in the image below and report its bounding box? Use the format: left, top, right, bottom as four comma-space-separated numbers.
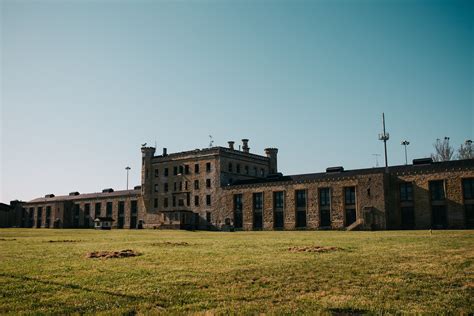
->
0, 0, 474, 203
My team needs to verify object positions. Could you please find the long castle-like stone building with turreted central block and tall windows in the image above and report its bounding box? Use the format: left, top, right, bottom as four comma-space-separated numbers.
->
6, 139, 474, 230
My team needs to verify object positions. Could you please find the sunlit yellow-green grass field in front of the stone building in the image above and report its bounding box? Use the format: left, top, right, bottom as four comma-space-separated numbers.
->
0, 229, 474, 314
